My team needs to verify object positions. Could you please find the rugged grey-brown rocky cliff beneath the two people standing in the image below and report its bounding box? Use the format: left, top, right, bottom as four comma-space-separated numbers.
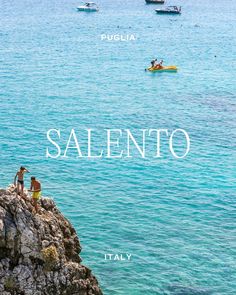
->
0, 188, 102, 295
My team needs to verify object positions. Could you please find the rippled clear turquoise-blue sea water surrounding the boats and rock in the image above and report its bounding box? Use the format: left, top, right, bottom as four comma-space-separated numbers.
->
0, 0, 236, 295
